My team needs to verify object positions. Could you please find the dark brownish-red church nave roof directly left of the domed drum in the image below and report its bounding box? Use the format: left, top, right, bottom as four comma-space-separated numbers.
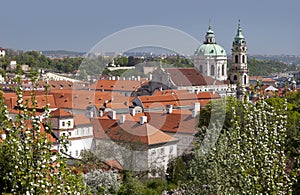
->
166, 68, 224, 86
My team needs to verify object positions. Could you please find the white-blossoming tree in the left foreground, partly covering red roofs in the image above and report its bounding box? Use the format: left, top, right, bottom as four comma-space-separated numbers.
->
0, 74, 89, 194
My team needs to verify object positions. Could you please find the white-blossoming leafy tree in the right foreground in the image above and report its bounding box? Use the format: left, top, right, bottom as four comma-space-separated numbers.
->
185, 97, 295, 194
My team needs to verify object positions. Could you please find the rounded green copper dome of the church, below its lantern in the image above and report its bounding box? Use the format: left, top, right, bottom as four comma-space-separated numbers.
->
195, 44, 226, 57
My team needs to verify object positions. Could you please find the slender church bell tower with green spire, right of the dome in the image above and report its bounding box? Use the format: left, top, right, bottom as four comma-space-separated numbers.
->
229, 21, 249, 86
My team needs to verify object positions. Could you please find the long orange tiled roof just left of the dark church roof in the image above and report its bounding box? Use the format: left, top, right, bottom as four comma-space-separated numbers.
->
87, 80, 143, 92
